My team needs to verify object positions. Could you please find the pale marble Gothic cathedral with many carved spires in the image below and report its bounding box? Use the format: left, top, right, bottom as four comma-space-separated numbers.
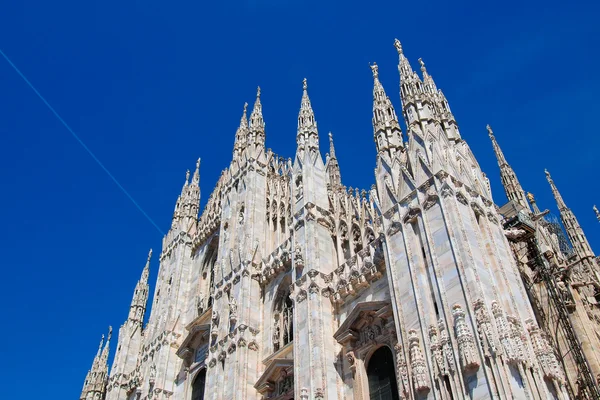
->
80, 40, 600, 400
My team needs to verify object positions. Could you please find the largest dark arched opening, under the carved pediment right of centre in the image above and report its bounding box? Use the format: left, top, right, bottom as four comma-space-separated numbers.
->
367, 346, 399, 400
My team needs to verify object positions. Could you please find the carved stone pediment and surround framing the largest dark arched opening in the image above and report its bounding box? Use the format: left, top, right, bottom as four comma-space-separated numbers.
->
334, 301, 398, 400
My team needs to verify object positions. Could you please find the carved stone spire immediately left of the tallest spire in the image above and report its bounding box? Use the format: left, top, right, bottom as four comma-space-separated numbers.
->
371, 63, 403, 153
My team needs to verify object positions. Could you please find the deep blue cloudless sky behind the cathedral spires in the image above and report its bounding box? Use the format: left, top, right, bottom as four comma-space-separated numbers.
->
0, 0, 600, 399
